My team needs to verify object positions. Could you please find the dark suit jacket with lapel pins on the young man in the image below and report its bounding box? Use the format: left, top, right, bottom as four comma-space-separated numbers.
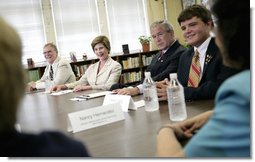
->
177, 38, 238, 100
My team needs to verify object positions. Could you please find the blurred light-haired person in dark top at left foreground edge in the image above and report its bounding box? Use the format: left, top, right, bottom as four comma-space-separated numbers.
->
0, 18, 89, 157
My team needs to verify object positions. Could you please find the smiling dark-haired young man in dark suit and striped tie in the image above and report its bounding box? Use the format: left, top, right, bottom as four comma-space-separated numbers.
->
157, 5, 237, 100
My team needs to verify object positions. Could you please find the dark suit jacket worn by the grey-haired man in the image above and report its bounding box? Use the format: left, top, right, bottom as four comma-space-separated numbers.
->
146, 41, 186, 81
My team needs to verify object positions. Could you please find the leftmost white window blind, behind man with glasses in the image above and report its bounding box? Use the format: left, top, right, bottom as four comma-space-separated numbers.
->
0, 0, 45, 64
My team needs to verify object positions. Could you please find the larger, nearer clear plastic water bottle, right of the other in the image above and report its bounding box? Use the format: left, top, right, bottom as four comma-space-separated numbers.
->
167, 73, 187, 121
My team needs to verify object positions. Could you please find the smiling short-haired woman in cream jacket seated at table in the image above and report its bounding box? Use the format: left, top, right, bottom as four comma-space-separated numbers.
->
51, 35, 122, 92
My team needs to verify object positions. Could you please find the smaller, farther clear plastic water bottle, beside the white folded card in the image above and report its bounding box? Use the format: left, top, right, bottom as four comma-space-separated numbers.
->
143, 72, 159, 111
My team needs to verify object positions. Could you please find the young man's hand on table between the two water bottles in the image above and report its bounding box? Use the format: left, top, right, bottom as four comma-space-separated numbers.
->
156, 79, 169, 101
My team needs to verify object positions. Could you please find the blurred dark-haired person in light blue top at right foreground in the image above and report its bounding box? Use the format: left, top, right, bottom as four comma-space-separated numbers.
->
157, 0, 251, 157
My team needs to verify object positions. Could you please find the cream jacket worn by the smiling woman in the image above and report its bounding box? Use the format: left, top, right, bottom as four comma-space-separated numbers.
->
66, 57, 122, 90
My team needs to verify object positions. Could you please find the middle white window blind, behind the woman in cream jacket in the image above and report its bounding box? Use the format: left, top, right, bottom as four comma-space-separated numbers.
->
52, 0, 100, 57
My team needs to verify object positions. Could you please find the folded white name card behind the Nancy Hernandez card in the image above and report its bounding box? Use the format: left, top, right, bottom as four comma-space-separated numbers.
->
103, 94, 137, 112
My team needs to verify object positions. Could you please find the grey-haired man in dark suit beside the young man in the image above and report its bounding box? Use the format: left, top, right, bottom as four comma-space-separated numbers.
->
111, 21, 185, 96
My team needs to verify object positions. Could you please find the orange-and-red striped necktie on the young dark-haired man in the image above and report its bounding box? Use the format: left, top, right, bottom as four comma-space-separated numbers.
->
188, 50, 201, 87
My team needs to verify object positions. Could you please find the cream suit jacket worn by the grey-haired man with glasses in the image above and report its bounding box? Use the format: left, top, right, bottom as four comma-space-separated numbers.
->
36, 57, 76, 89
